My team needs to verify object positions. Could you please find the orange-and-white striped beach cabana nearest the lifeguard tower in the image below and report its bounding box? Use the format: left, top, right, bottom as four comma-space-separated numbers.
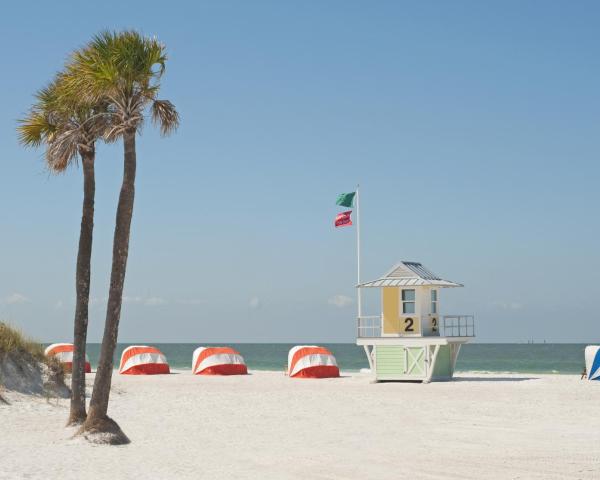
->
288, 345, 340, 378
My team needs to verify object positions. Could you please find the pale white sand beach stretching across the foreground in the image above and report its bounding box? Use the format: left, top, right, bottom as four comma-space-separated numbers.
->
0, 371, 600, 480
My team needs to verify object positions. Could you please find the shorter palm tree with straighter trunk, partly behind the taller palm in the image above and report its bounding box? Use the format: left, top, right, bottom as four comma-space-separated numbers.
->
18, 74, 107, 425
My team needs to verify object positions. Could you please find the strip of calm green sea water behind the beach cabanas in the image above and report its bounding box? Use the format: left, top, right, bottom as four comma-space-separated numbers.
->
81, 343, 585, 374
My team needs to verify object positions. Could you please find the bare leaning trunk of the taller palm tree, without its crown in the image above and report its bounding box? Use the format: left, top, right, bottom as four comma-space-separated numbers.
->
82, 129, 136, 444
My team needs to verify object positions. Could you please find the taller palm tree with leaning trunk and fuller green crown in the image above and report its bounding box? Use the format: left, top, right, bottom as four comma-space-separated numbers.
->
67, 31, 179, 444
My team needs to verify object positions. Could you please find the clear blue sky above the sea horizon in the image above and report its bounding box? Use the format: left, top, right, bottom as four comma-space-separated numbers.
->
0, 0, 600, 343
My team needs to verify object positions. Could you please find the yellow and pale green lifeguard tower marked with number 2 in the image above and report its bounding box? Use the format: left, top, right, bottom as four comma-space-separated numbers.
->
356, 262, 475, 383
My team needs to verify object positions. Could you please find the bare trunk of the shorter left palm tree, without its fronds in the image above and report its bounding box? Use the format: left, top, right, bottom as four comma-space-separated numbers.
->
68, 148, 96, 425
